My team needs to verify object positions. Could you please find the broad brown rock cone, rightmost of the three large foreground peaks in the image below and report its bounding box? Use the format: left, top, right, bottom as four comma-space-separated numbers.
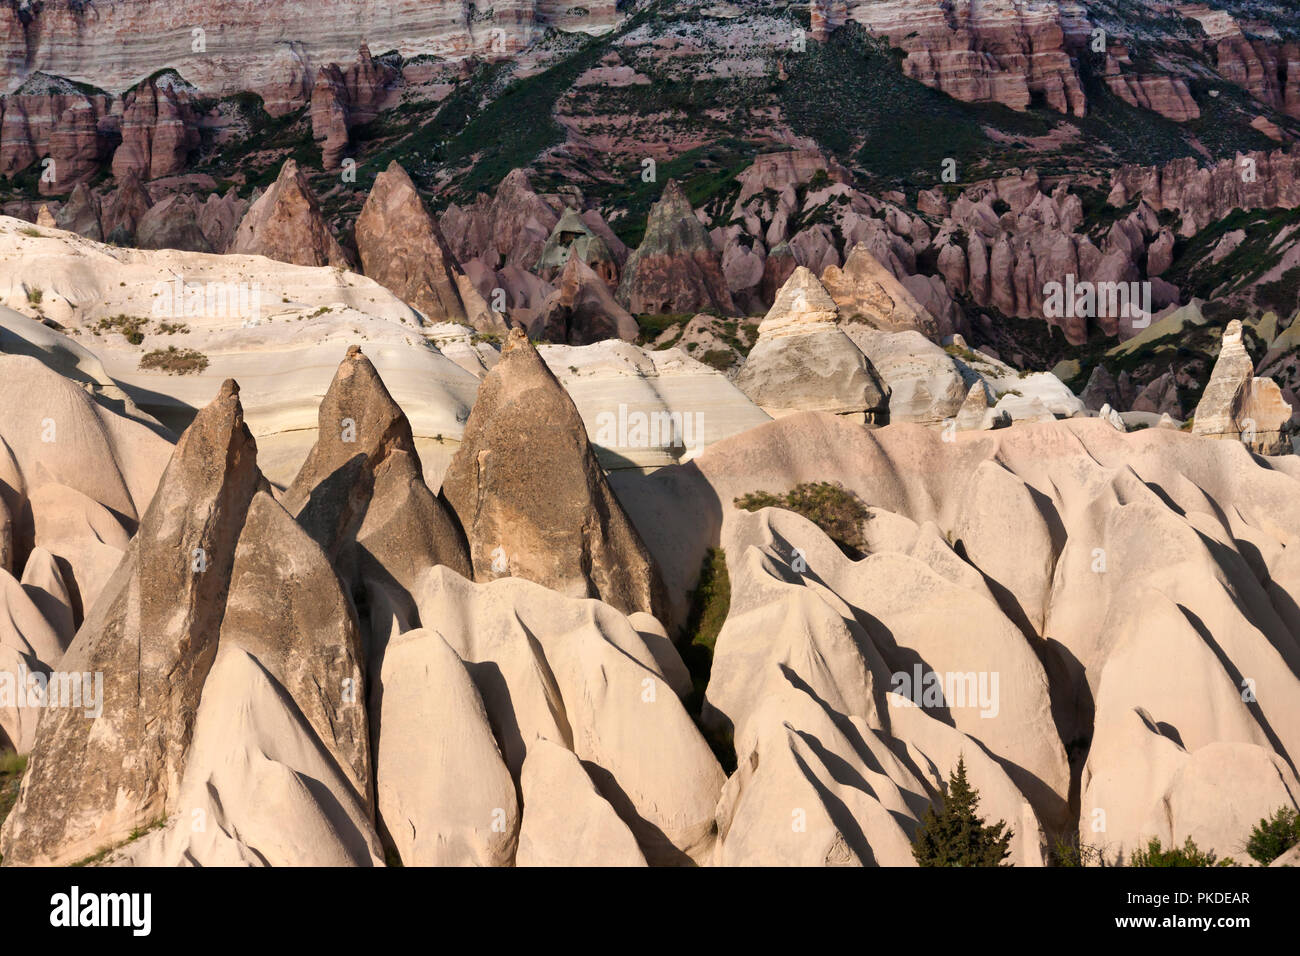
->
442, 329, 670, 624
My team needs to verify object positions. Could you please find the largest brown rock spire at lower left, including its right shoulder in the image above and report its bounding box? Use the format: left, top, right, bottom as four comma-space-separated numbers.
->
0, 380, 373, 864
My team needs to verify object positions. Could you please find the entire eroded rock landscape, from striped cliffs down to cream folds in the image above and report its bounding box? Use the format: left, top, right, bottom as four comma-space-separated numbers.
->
0, 0, 1300, 866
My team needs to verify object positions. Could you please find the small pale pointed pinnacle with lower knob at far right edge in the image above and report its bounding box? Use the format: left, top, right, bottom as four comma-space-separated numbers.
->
1192, 319, 1291, 455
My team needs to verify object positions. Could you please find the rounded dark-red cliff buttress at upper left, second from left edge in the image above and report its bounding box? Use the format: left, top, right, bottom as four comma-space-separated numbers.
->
113, 79, 199, 179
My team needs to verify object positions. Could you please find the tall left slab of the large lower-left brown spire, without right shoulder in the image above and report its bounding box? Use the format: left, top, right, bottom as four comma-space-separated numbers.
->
3, 382, 260, 864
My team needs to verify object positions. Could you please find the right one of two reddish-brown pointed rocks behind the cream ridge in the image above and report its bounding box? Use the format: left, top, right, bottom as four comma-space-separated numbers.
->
356, 160, 506, 332
